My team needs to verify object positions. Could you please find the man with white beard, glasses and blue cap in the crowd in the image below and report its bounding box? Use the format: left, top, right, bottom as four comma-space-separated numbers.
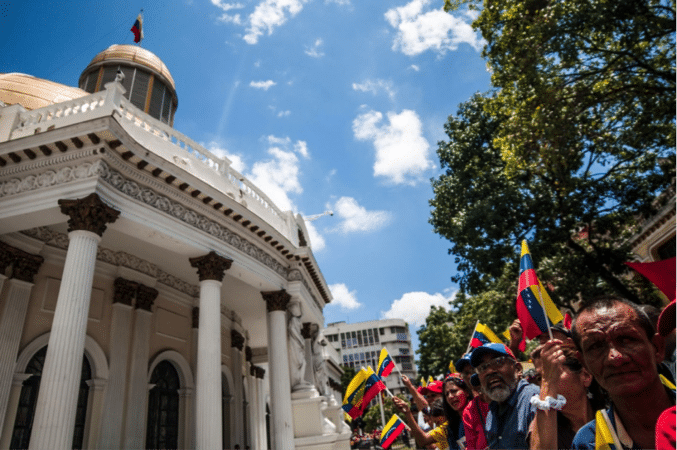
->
470, 344, 539, 449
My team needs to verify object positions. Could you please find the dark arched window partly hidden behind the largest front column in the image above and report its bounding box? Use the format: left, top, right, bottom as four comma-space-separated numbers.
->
10, 346, 92, 450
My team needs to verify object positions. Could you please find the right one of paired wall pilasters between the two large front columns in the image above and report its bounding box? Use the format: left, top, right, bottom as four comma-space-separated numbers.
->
120, 284, 158, 450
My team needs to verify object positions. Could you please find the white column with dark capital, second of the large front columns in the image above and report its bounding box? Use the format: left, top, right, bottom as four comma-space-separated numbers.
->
190, 251, 233, 450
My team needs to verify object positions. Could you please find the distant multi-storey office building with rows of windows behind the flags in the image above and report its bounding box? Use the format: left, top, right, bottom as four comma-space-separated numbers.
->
324, 319, 416, 394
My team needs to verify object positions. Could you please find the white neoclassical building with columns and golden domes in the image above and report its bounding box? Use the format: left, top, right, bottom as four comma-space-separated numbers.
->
0, 45, 350, 450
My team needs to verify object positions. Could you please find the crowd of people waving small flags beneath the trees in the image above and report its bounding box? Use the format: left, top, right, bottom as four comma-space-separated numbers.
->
393, 297, 677, 450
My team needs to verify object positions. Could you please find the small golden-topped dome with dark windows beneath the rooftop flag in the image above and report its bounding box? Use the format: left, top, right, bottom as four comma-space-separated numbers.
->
78, 45, 179, 125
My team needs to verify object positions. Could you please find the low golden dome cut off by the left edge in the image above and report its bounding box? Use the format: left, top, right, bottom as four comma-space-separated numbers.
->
0, 73, 89, 110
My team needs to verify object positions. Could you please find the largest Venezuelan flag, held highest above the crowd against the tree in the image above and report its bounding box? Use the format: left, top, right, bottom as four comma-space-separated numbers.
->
517, 240, 563, 339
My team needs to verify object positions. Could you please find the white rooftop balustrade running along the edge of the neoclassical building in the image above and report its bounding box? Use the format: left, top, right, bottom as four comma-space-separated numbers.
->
4, 83, 297, 242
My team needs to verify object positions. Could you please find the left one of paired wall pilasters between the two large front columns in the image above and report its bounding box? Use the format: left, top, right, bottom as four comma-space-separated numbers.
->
98, 278, 139, 448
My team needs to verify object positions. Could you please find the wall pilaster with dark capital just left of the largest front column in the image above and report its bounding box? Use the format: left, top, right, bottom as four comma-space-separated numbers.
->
0, 249, 44, 430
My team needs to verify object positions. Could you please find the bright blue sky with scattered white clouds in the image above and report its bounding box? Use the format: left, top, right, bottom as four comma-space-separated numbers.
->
0, 0, 490, 352
